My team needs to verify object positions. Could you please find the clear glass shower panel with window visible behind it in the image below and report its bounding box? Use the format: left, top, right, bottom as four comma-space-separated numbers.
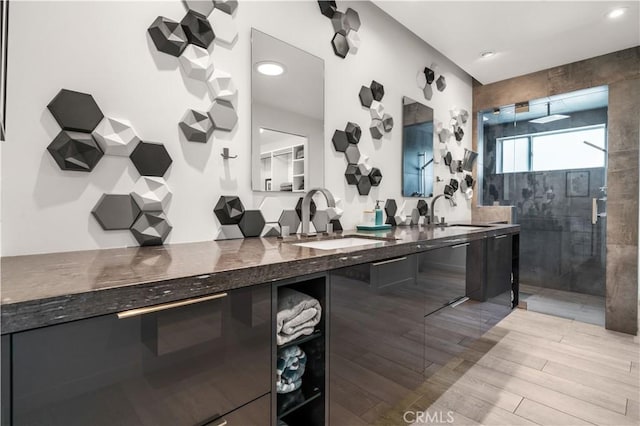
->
479, 86, 608, 323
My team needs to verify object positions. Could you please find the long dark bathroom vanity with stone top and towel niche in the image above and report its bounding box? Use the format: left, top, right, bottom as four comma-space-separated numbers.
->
1, 225, 519, 426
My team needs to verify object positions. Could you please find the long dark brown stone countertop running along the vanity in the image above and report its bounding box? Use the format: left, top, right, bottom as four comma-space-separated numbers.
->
0, 225, 520, 334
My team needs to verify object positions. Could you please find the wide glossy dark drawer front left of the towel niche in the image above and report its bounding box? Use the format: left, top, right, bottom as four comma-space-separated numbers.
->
12, 285, 271, 426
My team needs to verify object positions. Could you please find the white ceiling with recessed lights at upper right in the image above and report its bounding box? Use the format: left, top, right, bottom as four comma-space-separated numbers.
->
372, 0, 640, 84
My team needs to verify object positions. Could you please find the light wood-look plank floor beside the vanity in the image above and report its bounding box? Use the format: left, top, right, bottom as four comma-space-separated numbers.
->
384, 309, 640, 425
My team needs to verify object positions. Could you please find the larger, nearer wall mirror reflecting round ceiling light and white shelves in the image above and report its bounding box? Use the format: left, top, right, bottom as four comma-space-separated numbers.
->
251, 29, 324, 192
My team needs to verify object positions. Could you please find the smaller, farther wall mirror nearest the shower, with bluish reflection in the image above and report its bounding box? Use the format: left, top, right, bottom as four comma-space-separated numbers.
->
402, 96, 434, 197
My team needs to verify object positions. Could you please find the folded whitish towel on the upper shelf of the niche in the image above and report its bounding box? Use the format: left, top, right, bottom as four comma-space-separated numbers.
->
277, 288, 322, 345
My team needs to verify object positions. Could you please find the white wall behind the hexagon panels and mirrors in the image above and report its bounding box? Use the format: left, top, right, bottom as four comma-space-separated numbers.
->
1, 0, 471, 255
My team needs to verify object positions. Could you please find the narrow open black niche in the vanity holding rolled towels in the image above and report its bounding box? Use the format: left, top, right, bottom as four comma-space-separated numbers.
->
271, 274, 329, 426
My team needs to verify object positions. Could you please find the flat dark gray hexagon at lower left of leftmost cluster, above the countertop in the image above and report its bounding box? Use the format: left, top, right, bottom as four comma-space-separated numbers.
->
91, 194, 140, 231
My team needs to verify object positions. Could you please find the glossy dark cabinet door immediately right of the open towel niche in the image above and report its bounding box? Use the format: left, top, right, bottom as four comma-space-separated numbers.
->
329, 262, 424, 425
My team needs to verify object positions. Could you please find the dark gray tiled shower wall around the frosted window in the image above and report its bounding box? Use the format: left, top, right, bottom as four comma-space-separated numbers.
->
482, 108, 607, 296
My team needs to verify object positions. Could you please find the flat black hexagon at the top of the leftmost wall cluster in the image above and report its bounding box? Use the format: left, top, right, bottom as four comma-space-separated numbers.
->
47, 89, 104, 132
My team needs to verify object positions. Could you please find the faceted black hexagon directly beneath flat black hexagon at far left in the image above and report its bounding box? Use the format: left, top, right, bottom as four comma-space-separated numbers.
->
47, 130, 103, 172
